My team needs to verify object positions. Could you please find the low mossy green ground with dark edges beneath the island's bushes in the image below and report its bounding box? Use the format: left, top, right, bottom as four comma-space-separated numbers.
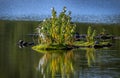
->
32, 41, 112, 53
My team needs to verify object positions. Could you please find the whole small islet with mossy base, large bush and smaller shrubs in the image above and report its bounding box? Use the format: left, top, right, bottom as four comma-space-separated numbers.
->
32, 7, 112, 51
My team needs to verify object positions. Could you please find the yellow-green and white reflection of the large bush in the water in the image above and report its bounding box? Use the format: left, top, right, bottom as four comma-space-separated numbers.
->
38, 51, 74, 77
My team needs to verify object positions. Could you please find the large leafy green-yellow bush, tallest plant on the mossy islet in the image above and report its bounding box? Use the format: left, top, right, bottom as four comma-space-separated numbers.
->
37, 7, 76, 44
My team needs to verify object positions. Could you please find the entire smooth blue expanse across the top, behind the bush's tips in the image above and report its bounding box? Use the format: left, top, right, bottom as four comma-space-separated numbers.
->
0, 0, 120, 21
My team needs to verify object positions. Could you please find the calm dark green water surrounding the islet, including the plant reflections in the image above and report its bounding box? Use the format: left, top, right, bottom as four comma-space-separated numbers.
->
0, 21, 120, 78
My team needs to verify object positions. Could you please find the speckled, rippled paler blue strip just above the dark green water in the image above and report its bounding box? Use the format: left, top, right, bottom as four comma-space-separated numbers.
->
0, 15, 120, 23
